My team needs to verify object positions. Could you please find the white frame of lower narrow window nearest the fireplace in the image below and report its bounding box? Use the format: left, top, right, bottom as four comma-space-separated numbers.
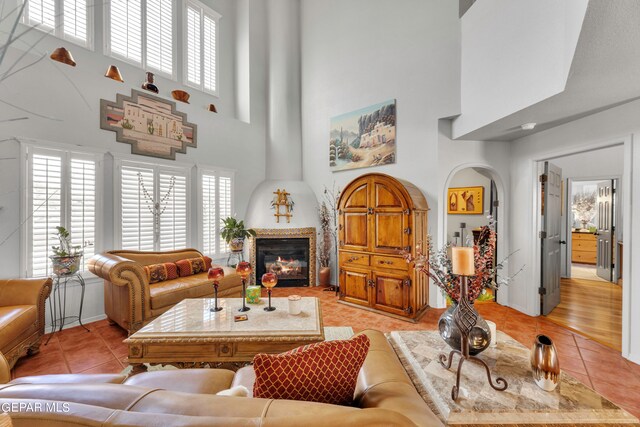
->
196, 165, 236, 259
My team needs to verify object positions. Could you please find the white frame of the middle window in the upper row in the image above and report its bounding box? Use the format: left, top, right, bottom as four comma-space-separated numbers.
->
103, 0, 179, 81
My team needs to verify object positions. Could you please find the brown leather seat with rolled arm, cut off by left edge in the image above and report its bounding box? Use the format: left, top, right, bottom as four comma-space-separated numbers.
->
0, 278, 52, 367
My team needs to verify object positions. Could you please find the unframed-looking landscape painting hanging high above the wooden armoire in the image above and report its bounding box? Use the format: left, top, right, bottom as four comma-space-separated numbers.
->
329, 99, 396, 171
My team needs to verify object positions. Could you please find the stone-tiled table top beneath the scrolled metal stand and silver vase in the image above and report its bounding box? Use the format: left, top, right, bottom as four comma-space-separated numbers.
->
388, 331, 638, 425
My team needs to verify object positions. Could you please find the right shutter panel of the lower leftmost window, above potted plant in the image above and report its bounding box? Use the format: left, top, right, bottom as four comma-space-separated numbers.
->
69, 158, 96, 270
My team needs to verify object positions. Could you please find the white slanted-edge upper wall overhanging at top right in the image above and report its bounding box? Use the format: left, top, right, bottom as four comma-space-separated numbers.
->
453, 0, 588, 138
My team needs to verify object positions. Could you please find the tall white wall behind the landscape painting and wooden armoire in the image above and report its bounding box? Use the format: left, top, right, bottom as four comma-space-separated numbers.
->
300, 0, 460, 303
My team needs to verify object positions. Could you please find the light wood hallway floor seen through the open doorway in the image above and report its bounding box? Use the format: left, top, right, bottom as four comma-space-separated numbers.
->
547, 278, 622, 351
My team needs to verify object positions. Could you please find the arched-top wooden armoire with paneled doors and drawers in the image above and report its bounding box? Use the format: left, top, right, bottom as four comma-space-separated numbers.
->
338, 173, 429, 321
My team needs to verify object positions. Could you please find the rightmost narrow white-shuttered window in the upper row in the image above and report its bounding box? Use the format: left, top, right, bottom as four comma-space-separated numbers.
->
184, 0, 220, 95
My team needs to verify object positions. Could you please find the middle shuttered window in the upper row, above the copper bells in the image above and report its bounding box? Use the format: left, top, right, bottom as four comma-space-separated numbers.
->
105, 0, 175, 78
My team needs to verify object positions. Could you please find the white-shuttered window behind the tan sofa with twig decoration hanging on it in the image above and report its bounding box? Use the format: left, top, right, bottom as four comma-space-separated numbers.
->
116, 161, 190, 251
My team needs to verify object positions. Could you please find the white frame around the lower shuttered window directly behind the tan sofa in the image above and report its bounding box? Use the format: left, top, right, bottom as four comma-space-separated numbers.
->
113, 154, 194, 251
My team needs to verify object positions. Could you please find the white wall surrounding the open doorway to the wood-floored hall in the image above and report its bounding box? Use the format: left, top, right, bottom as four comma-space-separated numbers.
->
510, 101, 640, 362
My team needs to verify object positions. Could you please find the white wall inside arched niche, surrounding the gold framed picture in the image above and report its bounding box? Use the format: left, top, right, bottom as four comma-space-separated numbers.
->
443, 167, 491, 244
